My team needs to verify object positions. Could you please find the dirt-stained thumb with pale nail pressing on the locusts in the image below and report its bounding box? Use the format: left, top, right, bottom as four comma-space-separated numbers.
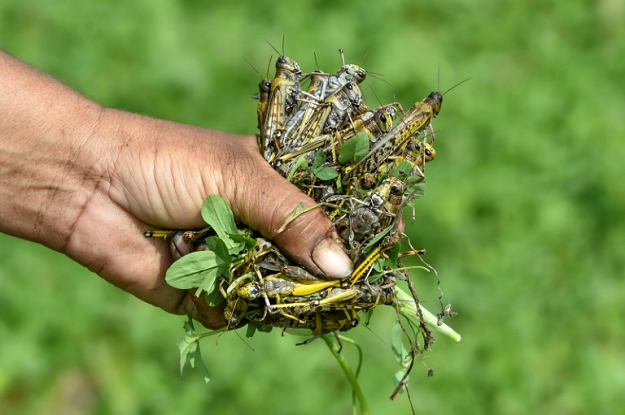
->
224, 136, 353, 278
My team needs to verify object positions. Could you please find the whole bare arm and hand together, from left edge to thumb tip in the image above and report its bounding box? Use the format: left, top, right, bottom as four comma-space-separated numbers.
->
0, 52, 352, 328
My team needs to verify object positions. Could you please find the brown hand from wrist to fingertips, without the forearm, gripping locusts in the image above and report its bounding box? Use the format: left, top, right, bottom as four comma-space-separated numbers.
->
66, 110, 351, 327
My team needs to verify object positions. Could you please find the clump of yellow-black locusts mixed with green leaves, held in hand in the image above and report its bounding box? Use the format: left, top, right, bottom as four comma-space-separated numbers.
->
146, 46, 460, 400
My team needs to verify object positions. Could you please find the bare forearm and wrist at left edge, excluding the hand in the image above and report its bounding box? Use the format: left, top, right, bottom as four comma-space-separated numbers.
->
0, 51, 102, 251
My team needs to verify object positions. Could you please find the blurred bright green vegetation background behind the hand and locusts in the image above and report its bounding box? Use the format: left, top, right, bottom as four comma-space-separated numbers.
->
0, 0, 625, 414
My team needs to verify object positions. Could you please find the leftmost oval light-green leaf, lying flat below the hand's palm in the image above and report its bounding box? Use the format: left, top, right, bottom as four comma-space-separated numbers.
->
165, 251, 227, 291
